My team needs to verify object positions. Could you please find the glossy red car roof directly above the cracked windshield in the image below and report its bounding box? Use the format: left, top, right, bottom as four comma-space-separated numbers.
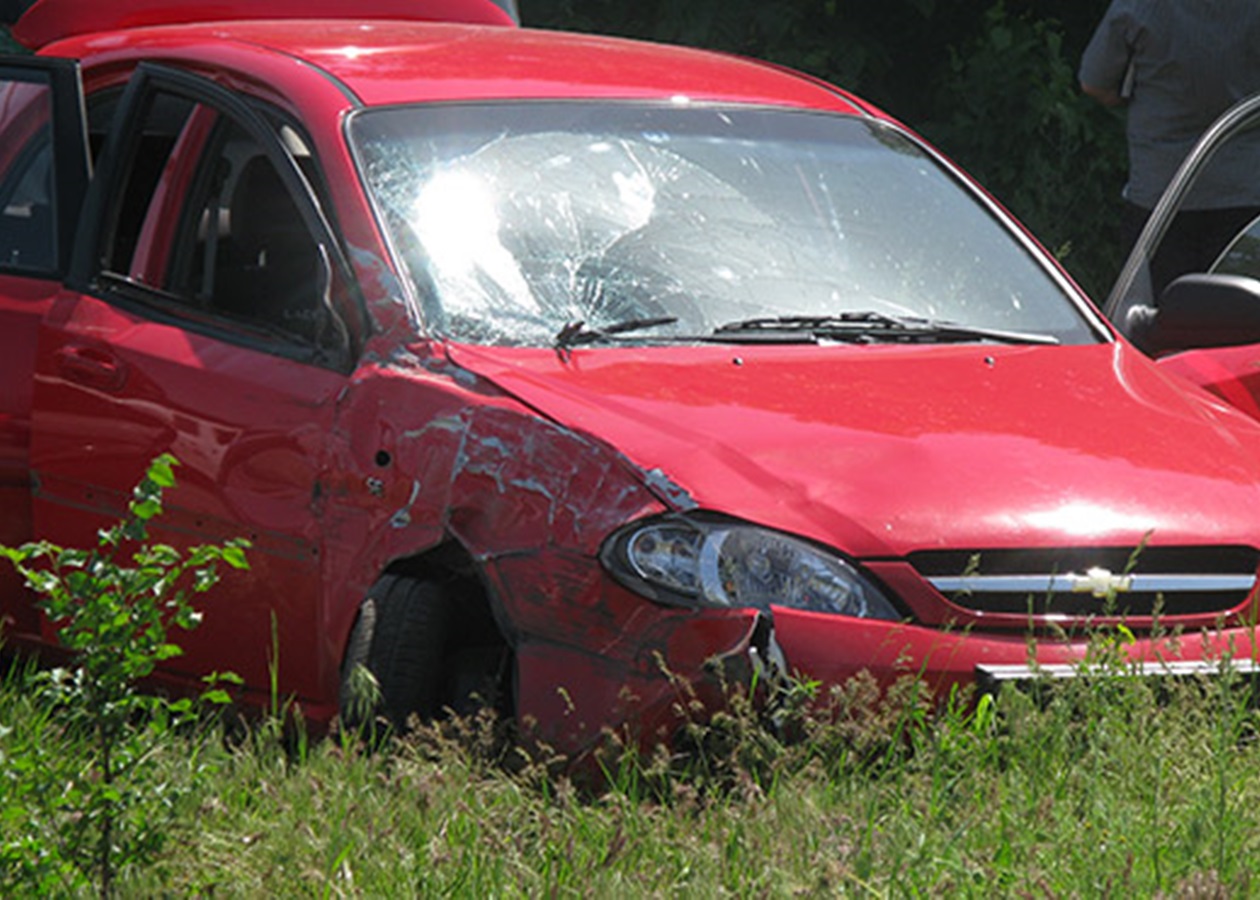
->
42, 19, 872, 112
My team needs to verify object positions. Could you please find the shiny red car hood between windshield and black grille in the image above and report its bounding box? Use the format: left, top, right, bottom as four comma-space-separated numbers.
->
449, 343, 1260, 558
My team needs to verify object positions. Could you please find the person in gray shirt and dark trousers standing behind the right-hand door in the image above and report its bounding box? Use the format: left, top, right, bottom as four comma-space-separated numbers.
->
1079, 0, 1260, 297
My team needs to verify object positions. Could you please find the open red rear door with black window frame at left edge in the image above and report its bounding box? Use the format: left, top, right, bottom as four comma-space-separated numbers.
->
0, 57, 88, 639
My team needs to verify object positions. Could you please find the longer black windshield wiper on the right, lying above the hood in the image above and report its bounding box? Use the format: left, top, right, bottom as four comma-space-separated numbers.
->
713, 310, 1058, 344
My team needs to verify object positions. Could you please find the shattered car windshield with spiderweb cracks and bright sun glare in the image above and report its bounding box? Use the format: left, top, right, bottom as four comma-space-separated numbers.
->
349, 102, 1097, 347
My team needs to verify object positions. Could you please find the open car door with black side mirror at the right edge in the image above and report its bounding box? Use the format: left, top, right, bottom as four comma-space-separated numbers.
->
1104, 95, 1260, 418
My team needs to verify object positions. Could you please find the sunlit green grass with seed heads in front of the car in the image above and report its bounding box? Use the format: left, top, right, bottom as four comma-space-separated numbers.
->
7, 650, 1260, 897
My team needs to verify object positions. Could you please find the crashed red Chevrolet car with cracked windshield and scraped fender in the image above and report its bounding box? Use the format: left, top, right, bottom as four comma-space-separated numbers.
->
0, 0, 1260, 751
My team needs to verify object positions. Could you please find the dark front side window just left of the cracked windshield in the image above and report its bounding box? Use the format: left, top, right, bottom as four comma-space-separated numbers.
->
95, 82, 344, 343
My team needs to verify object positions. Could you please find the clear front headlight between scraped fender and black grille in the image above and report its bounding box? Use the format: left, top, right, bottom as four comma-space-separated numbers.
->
601, 517, 902, 621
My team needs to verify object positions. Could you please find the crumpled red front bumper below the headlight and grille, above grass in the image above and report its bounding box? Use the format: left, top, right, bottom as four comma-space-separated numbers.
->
518, 594, 1260, 755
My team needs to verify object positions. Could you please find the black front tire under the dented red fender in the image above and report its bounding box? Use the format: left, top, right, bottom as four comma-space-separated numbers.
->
340, 575, 451, 730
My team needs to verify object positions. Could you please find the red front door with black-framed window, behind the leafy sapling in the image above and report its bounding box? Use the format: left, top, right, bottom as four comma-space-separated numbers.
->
33, 66, 352, 698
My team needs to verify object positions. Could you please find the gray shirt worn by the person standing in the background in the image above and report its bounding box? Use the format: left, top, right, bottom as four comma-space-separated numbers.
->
1080, 0, 1260, 209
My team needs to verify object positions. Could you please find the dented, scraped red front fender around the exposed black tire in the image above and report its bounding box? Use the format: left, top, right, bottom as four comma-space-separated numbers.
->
321, 337, 720, 739
